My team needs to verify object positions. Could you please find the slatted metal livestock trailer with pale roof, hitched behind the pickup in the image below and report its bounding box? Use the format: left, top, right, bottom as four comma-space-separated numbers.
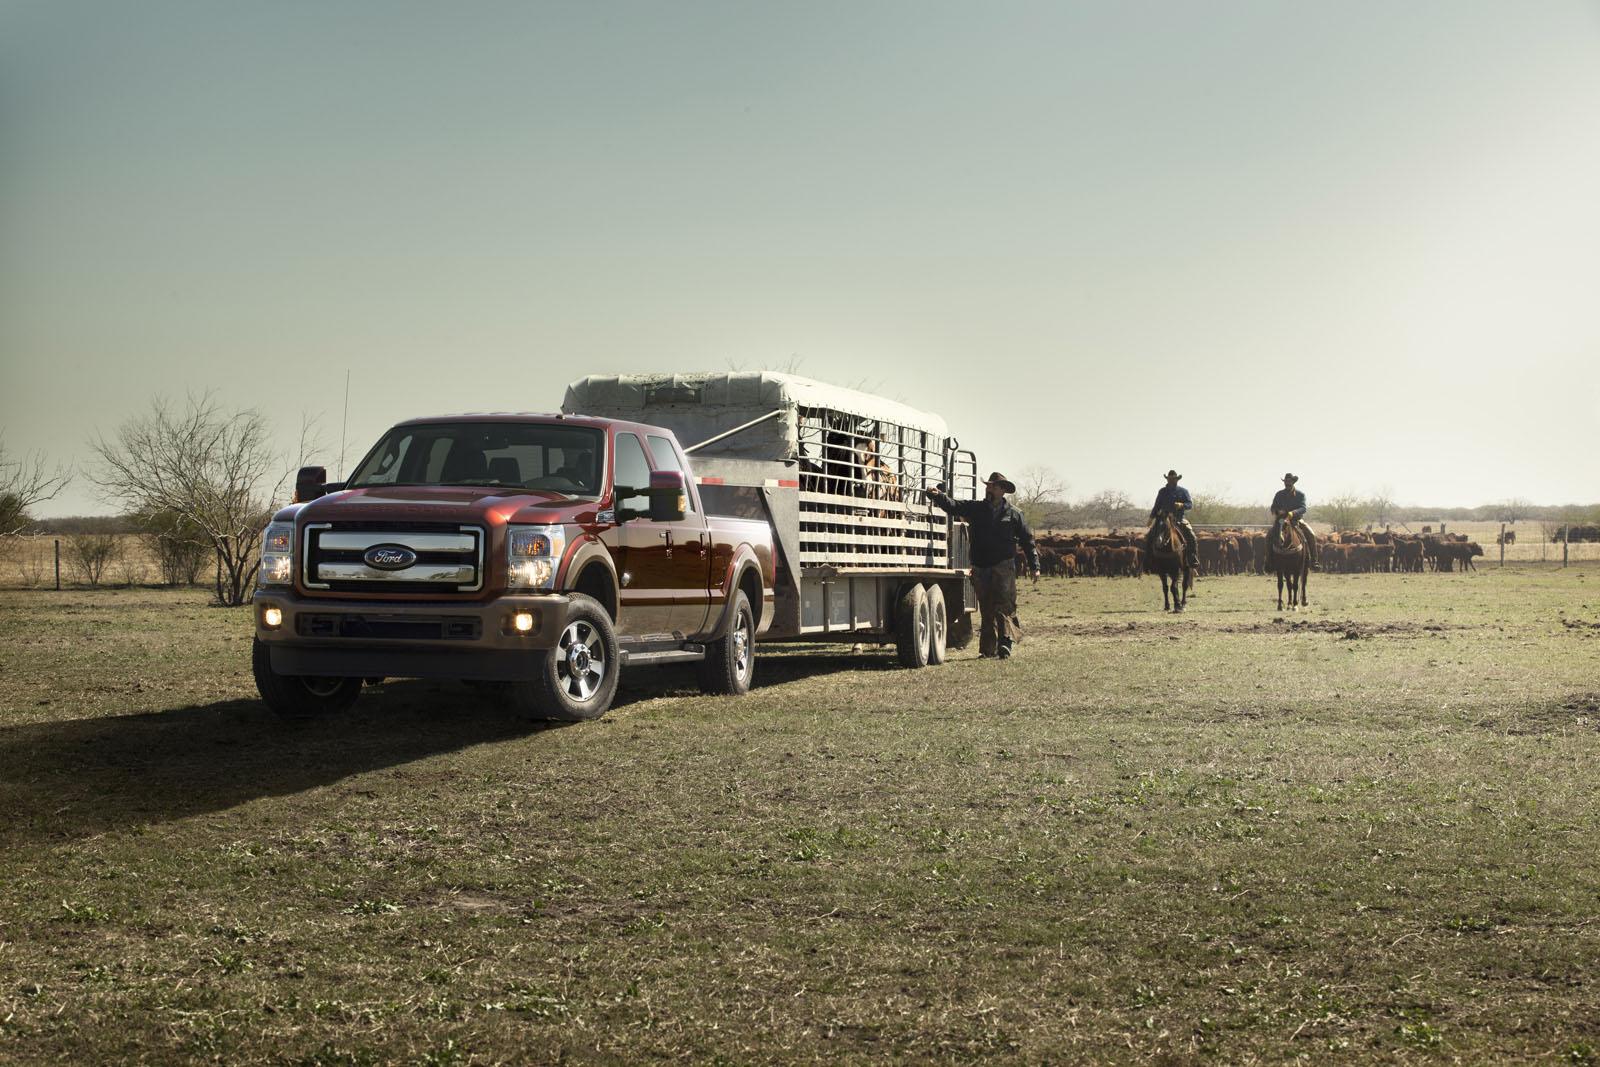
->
562, 371, 978, 665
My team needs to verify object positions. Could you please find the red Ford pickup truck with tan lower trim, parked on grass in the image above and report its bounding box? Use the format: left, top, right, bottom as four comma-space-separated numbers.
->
253, 414, 774, 720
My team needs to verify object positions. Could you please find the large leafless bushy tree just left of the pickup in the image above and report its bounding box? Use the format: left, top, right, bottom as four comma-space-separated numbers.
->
91, 394, 306, 605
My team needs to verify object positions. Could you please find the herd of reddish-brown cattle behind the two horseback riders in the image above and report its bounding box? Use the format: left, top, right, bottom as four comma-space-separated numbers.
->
1037, 530, 1483, 577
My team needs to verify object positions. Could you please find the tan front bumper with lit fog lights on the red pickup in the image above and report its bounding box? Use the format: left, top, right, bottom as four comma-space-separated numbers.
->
253, 589, 571, 681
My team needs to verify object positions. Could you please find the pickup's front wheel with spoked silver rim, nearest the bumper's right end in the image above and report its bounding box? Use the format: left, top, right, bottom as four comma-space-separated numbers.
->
506, 593, 622, 723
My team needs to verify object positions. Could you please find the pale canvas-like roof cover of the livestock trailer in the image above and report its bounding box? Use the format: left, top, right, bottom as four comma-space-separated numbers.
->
562, 371, 949, 443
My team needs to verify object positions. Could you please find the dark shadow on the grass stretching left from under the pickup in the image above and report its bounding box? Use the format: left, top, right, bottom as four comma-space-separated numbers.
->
0, 681, 576, 848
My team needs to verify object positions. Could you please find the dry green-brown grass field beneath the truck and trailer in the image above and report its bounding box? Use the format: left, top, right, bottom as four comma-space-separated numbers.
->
0, 566, 1600, 1064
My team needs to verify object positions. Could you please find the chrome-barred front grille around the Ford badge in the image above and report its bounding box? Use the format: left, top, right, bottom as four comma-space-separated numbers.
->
301, 523, 485, 593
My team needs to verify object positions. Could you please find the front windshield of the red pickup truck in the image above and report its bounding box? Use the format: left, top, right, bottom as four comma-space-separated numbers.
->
349, 422, 605, 496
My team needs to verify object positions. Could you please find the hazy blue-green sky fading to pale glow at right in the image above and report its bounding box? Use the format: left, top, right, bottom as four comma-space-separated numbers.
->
0, 0, 1600, 515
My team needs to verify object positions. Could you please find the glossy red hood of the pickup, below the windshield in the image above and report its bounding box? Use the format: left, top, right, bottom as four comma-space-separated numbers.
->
278, 485, 600, 526
